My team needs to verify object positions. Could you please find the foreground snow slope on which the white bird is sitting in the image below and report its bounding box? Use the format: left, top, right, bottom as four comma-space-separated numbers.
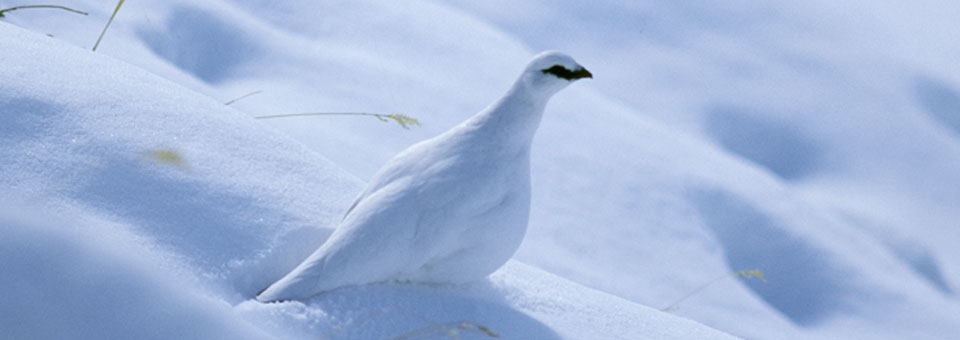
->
0, 19, 732, 339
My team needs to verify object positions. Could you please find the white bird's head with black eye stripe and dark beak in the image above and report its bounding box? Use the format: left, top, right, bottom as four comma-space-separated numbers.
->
521, 51, 593, 95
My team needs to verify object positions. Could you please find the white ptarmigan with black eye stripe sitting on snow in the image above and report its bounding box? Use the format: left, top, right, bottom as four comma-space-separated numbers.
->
257, 52, 593, 302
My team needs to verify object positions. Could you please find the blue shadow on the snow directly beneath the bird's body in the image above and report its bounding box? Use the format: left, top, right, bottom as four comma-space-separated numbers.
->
236, 281, 561, 340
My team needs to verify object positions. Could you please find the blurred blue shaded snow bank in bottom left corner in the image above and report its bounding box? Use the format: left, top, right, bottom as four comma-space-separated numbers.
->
0, 206, 269, 339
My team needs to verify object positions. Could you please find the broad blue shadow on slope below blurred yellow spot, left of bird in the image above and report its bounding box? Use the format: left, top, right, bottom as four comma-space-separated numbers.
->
75, 159, 288, 272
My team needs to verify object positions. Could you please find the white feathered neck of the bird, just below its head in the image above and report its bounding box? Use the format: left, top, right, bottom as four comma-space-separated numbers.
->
470, 81, 550, 148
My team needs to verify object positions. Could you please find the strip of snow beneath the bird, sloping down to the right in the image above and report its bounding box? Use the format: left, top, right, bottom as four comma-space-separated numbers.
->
237, 262, 732, 339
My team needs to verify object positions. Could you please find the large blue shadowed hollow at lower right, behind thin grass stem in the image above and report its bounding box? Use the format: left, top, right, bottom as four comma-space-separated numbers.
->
693, 190, 856, 326
